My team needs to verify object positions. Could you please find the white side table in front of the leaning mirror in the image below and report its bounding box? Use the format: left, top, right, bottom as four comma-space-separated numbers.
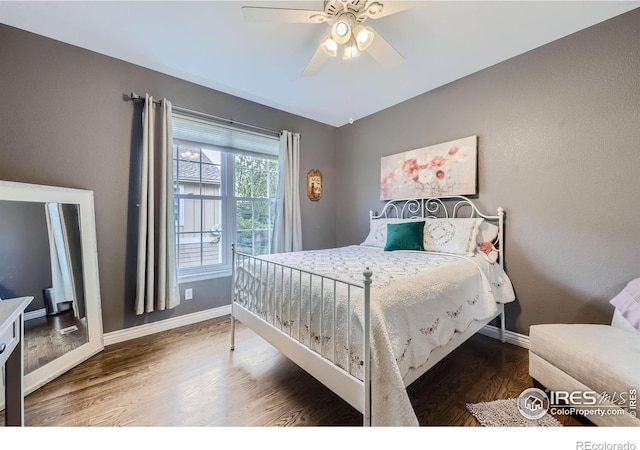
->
0, 297, 33, 427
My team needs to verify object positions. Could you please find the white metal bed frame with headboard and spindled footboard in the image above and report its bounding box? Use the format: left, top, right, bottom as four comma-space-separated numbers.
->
231, 196, 505, 426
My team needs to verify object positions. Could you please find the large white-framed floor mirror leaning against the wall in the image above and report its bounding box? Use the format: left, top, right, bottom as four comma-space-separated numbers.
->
0, 181, 104, 405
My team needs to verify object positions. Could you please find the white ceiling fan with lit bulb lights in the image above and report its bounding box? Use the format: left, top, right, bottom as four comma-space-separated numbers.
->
242, 0, 414, 76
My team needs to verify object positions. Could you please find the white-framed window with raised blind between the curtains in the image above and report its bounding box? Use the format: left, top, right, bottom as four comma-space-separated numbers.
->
173, 114, 279, 280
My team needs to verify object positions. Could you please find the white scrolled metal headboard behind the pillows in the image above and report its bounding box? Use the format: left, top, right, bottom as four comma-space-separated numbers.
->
369, 195, 505, 268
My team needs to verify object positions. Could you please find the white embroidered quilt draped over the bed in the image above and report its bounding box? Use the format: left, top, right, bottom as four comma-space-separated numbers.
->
236, 246, 515, 426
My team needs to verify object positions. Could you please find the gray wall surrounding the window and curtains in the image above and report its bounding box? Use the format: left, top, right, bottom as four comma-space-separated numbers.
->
0, 24, 337, 332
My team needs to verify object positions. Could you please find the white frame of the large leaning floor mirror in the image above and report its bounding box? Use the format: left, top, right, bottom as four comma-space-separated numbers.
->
0, 181, 104, 395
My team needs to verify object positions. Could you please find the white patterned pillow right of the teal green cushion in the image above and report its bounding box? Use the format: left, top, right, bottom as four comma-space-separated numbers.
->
424, 218, 484, 256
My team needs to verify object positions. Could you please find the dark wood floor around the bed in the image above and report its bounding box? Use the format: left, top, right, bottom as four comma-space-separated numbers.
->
0, 318, 582, 427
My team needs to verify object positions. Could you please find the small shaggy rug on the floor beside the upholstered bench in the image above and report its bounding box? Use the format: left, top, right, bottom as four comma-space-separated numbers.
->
467, 398, 562, 427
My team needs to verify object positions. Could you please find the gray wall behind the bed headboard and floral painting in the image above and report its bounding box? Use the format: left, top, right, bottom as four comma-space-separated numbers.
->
336, 9, 640, 334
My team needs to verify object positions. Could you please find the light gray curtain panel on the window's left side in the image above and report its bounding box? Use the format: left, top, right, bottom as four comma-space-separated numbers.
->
136, 94, 180, 314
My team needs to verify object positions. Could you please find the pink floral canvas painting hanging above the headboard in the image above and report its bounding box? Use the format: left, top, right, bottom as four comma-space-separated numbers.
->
380, 136, 478, 200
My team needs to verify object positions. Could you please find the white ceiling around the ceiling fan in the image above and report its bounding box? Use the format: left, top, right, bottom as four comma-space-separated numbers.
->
0, 0, 640, 126
